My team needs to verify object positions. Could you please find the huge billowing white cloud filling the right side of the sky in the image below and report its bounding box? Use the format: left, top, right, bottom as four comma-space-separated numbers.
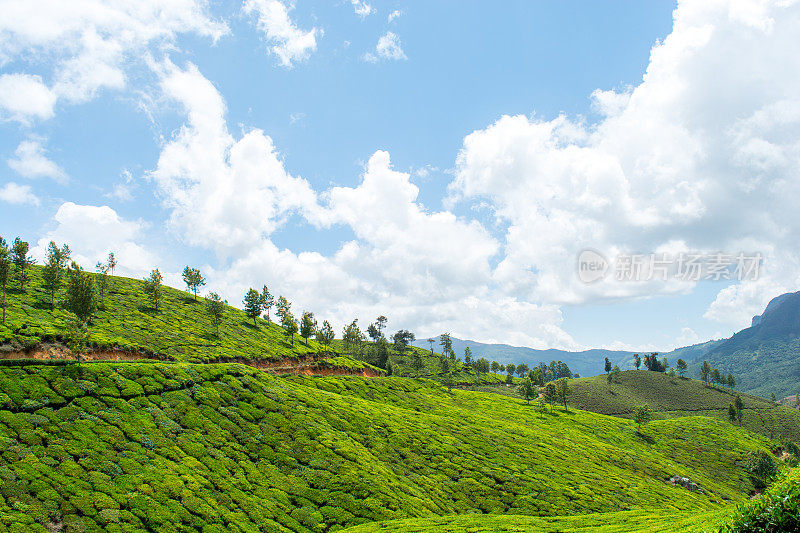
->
450, 0, 800, 328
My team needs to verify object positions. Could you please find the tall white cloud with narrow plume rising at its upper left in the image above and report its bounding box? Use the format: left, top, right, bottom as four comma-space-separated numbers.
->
149, 61, 318, 256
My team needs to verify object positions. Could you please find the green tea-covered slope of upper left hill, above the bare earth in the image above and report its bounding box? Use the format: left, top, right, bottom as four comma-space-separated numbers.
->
0, 267, 356, 362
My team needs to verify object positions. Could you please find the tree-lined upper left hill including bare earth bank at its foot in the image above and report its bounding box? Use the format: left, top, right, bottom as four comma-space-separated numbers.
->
0, 266, 377, 373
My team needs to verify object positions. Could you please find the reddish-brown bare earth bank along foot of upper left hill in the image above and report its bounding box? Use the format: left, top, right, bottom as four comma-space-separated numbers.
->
0, 343, 382, 377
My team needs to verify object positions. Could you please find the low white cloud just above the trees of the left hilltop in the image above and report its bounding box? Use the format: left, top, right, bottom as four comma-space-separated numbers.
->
31, 202, 157, 276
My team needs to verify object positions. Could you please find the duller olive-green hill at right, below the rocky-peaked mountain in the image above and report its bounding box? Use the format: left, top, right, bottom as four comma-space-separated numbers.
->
570, 370, 800, 442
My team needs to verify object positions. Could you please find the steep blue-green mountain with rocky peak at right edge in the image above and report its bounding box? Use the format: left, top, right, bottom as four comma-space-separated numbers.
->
696, 292, 800, 398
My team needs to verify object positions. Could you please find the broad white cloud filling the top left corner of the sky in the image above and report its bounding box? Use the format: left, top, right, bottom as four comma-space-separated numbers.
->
0, 0, 228, 121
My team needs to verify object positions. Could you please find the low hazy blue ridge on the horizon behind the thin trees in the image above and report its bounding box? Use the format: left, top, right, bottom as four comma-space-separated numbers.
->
414, 337, 634, 376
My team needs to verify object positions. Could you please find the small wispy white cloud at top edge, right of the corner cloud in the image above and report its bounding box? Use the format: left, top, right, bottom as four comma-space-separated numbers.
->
244, 0, 318, 67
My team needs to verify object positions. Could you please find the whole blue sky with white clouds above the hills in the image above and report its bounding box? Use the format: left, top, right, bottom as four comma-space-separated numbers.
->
0, 0, 800, 350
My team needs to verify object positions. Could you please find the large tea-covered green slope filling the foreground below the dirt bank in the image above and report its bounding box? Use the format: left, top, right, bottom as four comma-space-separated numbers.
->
0, 363, 769, 533
